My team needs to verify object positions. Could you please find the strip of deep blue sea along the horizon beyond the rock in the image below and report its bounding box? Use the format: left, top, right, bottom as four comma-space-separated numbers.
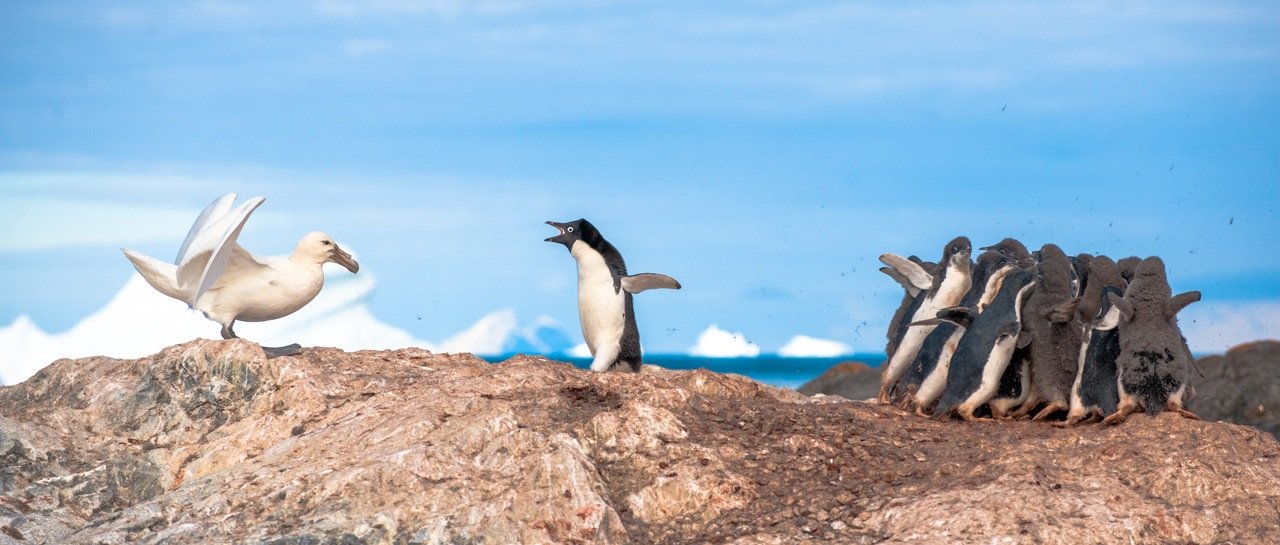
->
486, 353, 884, 389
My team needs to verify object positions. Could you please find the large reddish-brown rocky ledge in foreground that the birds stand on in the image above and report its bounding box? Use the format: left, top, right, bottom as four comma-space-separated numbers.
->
0, 340, 1280, 545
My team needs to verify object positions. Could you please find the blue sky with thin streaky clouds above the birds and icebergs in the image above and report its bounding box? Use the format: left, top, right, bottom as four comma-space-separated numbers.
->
0, 0, 1280, 352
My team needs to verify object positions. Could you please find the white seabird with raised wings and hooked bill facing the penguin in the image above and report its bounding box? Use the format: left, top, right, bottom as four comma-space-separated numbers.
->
123, 193, 360, 357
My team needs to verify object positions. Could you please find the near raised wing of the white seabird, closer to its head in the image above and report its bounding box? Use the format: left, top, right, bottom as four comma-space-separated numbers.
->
178, 197, 266, 307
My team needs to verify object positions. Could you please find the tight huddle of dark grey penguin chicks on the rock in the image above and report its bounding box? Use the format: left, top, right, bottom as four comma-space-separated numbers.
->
878, 237, 1199, 426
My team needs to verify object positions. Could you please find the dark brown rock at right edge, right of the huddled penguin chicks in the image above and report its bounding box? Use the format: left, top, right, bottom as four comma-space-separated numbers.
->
1188, 340, 1280, 438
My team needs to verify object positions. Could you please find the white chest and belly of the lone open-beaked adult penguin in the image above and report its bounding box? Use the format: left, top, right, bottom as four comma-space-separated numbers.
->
570, 242, 626, 354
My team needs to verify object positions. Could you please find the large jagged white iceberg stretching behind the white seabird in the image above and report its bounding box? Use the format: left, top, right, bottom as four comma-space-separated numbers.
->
0, 266, 585, 385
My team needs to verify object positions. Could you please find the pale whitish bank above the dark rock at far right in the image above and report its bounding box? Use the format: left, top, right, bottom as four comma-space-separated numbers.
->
1178, 301, 1280, 354
